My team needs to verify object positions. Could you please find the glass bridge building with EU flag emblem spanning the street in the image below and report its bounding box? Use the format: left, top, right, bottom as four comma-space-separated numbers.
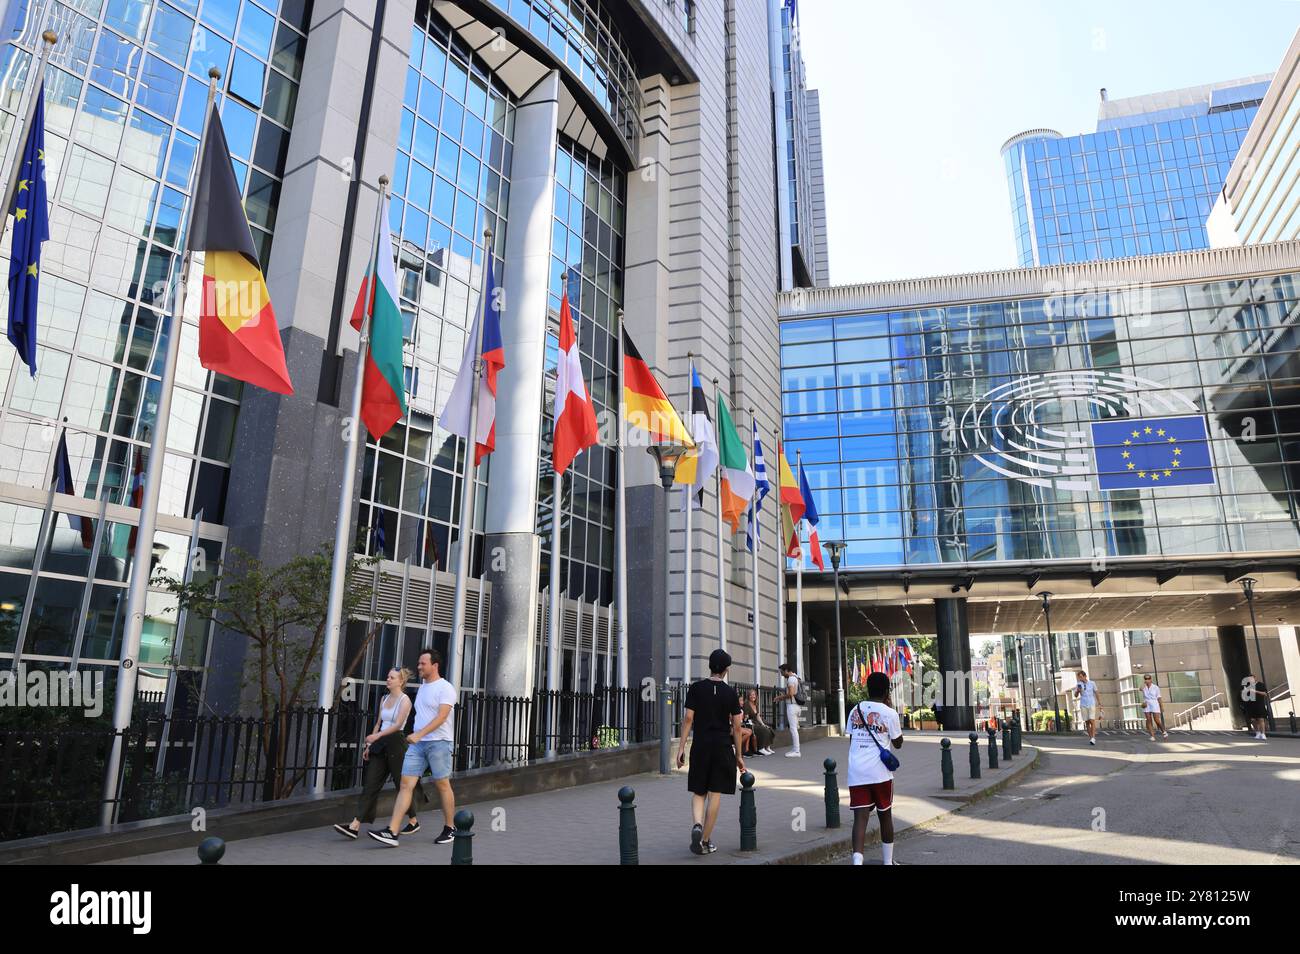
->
781, 242, 1300, 728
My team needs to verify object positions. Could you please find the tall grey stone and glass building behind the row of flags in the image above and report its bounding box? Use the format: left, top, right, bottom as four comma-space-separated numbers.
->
0, 0, 826, 712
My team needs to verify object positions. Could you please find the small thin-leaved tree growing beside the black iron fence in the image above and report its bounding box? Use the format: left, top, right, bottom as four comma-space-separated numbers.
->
159, 547, 390, 798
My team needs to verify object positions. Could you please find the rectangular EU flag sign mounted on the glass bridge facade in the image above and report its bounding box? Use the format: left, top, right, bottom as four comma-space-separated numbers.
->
1092, 415, 1214, 490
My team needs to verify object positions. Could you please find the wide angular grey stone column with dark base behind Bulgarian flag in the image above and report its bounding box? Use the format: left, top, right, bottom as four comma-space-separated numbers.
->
207, 0, 415, 712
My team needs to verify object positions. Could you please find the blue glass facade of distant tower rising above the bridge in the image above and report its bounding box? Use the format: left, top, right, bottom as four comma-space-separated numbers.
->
1002, 84, 1262, 268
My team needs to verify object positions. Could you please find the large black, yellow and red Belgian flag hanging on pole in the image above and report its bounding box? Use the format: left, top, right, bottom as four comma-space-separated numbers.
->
189, 105, 294, 394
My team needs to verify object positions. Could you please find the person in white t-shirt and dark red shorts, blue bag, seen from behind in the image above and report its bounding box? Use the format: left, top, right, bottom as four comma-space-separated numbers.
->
844, 672, 902, 864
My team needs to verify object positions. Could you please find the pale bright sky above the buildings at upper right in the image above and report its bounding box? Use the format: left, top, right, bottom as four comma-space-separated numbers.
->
800, 0, 1300, 283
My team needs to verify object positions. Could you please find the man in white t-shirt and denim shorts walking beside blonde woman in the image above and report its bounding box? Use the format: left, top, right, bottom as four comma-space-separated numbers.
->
367, 649, 456, 847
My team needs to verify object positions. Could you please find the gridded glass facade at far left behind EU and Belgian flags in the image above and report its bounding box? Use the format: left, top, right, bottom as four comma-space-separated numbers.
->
0, 0, 311, 690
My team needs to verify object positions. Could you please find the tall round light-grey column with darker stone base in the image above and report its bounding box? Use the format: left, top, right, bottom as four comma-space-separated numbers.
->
484, 70, 559, 695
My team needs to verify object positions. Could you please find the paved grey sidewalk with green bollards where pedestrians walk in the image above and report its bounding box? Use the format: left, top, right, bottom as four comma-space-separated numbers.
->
116, 732, 1036, 864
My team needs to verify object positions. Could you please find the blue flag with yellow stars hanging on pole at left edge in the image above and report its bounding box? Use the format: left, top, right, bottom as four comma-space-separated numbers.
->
9, 84, 49, 377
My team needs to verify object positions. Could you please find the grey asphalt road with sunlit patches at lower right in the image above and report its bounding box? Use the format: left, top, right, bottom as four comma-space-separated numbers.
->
836, 733, 1300, 864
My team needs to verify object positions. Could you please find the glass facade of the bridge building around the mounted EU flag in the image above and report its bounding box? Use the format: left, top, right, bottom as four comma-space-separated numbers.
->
781, 274, 1300, 567
